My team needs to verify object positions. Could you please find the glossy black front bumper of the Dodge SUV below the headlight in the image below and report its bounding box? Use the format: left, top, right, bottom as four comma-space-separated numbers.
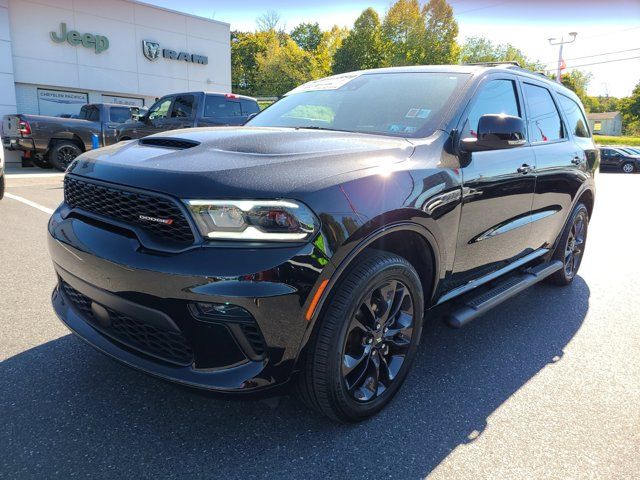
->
49, 209, 333, 393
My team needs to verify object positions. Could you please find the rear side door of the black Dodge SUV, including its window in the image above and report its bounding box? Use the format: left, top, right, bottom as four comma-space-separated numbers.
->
522, 79, 590, 247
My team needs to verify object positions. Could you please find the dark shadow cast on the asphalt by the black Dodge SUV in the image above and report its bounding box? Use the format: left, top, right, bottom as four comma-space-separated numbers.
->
0, 277, 590, 480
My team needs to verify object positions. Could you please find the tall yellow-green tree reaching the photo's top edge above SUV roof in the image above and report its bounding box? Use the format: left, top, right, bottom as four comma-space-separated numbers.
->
422, 0, 460, 65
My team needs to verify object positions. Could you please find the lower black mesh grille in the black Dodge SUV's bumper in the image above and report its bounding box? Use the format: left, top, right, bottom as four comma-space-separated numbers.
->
61, 281, 193, 365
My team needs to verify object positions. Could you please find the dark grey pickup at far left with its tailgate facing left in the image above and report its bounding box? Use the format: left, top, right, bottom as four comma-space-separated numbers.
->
2, 103, 144, 171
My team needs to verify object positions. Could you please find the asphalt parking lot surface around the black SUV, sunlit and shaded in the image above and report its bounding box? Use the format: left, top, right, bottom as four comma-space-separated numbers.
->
0, 167, 640, 480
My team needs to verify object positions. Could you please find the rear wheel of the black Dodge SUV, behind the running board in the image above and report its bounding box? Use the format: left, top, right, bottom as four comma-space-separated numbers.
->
547, 203, 589, 285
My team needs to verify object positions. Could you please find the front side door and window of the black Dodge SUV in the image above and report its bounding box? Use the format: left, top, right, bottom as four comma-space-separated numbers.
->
452, 73, 535, 286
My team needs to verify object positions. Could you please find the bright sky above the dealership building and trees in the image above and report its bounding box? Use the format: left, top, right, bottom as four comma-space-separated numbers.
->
143, 0, 640, 97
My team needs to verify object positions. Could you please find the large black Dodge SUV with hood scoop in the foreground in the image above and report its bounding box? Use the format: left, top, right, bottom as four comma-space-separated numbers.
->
49, 66, 598, 421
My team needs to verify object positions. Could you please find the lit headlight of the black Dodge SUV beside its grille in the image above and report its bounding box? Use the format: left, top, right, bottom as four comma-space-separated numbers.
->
185, 200, 319, 242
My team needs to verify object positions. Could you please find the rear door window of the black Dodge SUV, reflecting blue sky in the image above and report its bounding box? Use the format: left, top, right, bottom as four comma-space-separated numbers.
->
523, 83, 565, 143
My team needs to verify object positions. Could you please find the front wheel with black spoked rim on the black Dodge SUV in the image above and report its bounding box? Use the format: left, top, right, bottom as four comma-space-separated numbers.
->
296, 252, 424, 422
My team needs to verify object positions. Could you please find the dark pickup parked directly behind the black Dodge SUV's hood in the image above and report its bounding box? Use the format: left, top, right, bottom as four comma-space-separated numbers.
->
118, 92, 260, 140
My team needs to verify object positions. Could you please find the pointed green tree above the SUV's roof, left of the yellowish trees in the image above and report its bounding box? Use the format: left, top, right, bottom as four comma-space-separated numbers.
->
333, 8, 385, 73
